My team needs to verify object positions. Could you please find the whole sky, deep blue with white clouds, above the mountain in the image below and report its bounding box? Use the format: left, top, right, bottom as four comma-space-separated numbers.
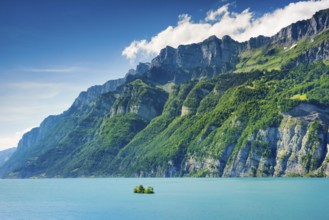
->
0, 0, 329, 150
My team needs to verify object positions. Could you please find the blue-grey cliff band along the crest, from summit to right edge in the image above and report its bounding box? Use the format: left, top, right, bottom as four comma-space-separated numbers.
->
150, 10, 329, 71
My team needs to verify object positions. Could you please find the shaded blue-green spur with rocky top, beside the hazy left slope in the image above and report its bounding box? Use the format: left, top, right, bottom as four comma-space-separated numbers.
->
57, 80, 168, 176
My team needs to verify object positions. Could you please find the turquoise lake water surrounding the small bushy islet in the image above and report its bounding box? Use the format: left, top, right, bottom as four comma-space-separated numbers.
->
0, 178, 329, 220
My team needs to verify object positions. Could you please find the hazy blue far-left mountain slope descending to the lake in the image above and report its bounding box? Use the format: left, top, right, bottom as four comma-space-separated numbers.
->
0, 79, 125, 177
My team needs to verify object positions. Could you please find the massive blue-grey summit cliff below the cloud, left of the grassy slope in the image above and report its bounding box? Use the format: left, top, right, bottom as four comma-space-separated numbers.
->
148, 36, 244, 83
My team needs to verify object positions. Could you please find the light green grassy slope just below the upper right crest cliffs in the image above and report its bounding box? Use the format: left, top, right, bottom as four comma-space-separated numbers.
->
235, 29, 329, 73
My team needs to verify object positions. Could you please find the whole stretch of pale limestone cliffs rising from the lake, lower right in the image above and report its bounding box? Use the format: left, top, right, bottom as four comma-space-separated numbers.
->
223, 104, 329, 176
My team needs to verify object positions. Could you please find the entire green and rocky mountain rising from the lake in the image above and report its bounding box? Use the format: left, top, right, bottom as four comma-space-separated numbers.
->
0, 10, 329, 178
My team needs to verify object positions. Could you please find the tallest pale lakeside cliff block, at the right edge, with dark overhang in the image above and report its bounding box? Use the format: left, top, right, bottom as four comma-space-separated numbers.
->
274, 104, 329, 176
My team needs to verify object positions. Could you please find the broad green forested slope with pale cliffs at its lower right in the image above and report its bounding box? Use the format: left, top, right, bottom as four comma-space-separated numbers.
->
109, 64, 329, 176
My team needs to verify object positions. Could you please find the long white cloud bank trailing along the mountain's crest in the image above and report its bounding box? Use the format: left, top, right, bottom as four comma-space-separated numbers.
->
122, 0, 329, 63
